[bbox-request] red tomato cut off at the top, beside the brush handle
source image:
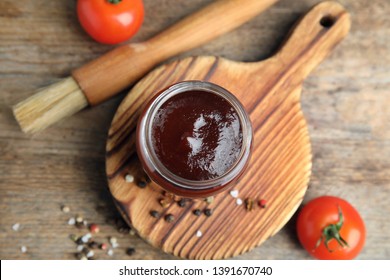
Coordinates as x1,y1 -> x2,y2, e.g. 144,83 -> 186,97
77,0 -> 144,44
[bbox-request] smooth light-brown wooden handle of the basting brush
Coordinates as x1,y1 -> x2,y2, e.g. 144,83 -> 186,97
72,0 -> 277,106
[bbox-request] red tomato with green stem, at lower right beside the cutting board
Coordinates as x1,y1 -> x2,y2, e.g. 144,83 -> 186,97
297,196 -> 366,260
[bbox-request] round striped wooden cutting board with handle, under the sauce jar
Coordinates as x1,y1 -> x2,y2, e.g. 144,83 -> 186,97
106,2 -> 350,259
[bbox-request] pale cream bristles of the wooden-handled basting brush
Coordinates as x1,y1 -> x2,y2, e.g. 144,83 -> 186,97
13,77 -> 88,133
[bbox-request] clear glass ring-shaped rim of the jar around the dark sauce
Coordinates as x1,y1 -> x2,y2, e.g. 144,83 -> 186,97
137,80 -> 252,190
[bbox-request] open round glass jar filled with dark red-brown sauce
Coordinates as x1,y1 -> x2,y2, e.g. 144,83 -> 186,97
136,81 -> 253,198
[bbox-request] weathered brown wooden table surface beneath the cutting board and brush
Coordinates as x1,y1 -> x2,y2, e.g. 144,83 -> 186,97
0,0 -> 390,259
